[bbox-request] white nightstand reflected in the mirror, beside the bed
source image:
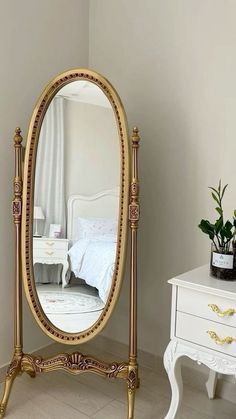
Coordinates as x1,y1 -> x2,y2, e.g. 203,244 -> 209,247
33,237 -> 69,288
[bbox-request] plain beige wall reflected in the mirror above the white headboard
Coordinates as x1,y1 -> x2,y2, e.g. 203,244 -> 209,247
65,100 -> 120,199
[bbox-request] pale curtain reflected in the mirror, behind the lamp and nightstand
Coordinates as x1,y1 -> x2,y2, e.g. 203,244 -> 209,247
34,97 -> 66,283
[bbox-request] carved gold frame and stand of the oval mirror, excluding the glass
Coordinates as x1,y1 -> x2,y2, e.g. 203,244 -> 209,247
0,69 -> 140,419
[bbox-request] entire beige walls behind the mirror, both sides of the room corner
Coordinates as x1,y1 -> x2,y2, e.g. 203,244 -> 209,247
0,0 -> 236,366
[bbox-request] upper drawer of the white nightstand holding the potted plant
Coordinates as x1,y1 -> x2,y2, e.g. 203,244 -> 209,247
177,287 -> 236,327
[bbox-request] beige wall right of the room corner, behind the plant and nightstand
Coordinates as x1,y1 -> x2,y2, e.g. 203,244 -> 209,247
89,0 -> 236,354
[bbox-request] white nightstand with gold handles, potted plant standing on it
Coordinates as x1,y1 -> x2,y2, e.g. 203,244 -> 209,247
164,265 -> 236,419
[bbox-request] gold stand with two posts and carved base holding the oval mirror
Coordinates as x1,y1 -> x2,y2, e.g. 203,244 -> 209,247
0,127 -> 140,419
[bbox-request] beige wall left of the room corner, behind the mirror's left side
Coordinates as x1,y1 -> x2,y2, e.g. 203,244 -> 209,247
0,0 -> 88,366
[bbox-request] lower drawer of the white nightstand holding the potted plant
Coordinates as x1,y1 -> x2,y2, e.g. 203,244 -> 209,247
176,312 -> 236,356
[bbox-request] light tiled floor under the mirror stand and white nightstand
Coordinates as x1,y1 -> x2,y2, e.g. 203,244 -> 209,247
1,344 -> 236,419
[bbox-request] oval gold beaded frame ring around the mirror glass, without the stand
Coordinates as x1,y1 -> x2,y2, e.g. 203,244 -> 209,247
21,69 -> 130,345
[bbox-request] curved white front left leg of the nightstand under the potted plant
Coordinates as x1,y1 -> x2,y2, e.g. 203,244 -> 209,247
164,342 -> 183,419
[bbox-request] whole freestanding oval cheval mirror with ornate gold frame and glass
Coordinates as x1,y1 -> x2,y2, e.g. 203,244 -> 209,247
0,69 -> 139,419
